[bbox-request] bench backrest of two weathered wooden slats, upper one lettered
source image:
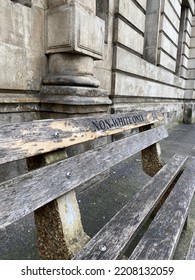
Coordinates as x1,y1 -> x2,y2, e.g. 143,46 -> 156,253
0,111 -> 168,228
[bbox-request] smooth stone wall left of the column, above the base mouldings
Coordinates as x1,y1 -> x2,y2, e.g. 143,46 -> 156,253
0,1 -> 46,90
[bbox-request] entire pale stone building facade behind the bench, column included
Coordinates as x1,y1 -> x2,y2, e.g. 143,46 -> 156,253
0,0 -> 195,125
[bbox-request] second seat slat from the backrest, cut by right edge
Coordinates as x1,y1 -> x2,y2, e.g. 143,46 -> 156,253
130,160 -> 195,260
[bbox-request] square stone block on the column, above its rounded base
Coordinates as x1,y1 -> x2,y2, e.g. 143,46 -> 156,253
46,4 -> 105,59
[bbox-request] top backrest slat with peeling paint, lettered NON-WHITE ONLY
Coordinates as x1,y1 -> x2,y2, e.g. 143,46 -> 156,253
0,111 -> 163,164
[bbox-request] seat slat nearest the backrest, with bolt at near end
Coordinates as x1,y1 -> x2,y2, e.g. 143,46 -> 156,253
75,155 -> 186,260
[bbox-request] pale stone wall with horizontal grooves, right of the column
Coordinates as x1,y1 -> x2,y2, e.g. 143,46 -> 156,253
108,0 -> 194,123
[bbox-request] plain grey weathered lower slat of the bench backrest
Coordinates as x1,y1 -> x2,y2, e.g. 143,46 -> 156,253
0,126 -> 167,228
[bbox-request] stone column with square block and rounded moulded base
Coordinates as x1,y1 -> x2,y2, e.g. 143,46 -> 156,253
41,0 -> 111,116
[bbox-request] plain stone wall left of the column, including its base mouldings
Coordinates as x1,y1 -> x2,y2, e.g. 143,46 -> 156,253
0,0 -> 46,123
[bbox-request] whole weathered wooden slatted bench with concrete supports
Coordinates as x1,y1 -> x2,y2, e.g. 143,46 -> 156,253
0,111 -> 195,259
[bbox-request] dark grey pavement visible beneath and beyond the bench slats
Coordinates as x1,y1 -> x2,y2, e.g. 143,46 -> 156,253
0,124 -> 195,259
